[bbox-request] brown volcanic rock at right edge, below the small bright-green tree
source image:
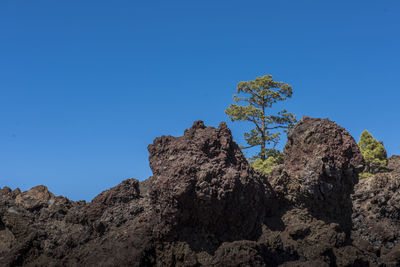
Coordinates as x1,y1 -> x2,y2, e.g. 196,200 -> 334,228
352,156 -> 400,266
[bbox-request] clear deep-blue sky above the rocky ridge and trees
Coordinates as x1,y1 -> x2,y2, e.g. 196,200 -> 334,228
0,0 -> 400,200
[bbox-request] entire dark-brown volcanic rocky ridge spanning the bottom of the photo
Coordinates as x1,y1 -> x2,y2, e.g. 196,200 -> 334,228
0,117 -> 400,266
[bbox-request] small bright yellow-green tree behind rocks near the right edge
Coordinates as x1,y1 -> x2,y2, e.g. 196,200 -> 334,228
358,130 -> 387,173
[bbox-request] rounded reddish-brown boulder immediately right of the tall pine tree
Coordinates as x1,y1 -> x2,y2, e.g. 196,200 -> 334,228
272,117 -> 364,224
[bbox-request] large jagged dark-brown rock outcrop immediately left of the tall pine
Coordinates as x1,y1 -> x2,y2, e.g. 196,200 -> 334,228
148,121 -> 271,246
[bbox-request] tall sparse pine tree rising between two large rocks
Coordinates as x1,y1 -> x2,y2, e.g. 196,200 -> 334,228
225,75 -> 296,161
